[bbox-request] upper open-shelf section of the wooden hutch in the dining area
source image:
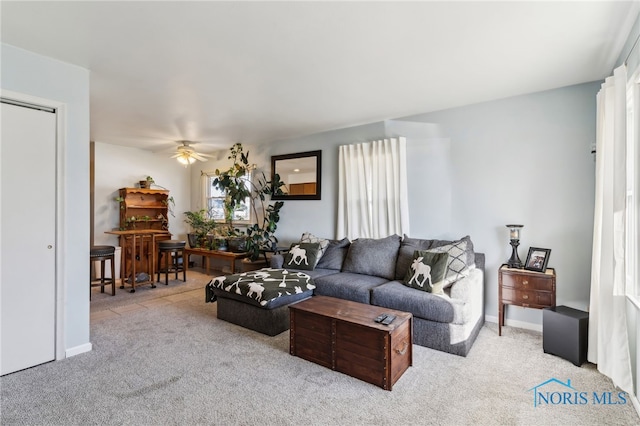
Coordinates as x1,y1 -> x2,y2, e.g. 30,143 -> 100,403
120,188 -> 169,230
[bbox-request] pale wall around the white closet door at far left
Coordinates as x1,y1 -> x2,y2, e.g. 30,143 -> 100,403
1,44 -> 91,355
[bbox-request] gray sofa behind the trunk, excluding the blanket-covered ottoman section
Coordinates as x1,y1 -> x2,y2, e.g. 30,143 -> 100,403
271,235 -> 484,356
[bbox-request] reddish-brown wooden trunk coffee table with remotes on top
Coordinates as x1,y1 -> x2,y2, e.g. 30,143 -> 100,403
289,296 -> 413,390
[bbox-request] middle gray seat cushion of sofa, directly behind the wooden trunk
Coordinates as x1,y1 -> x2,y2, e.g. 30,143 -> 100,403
313,272 -> 388,304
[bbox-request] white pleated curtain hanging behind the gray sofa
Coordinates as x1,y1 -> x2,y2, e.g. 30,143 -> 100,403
336,137 -> 409,240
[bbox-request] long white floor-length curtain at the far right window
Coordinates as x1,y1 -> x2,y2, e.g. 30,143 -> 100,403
587,66 -> 633,393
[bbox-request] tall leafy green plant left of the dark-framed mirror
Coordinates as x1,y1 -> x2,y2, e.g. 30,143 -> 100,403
213,143 -> 284,260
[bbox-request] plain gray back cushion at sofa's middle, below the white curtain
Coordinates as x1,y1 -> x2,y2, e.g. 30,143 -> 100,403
342,235 -> 406,280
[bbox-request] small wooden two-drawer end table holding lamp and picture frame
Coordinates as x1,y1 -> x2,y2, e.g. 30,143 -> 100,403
498,265 -> 556,336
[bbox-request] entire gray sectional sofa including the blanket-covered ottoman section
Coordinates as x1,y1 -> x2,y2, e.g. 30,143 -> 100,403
207,235 -> 485,356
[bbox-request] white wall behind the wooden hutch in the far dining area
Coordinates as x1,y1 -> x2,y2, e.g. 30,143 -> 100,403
94,142 -> 191,245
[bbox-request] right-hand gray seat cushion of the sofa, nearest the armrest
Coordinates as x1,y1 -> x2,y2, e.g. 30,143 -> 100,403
370,281 -> 471,324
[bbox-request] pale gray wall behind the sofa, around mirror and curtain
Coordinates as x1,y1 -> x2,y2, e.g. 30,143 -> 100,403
258,82 -> 600,329
